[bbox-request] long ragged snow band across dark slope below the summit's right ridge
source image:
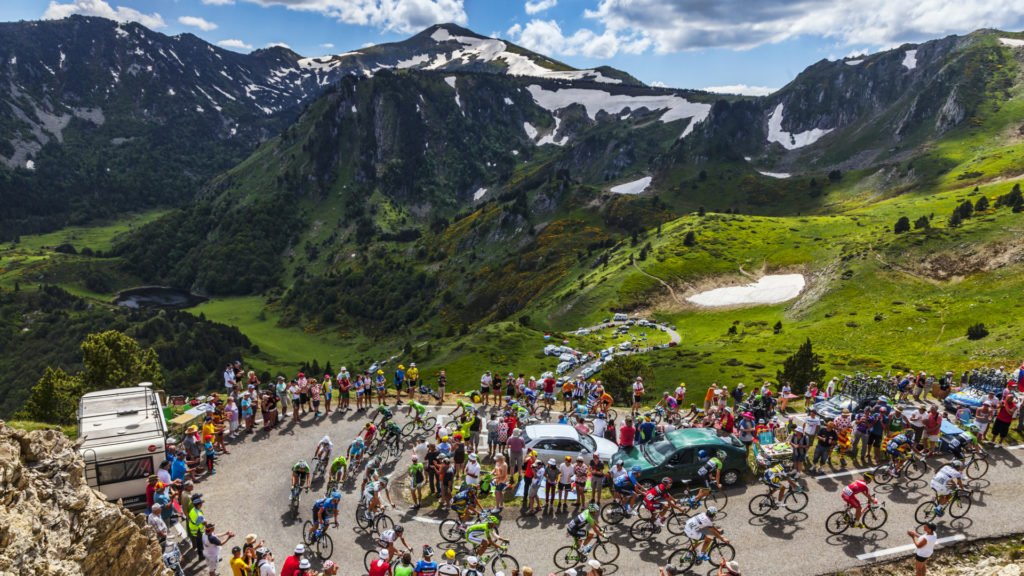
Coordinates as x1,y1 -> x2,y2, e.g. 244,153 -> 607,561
526,84 -> 711,138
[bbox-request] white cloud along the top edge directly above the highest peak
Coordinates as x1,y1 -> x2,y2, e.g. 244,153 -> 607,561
239,0 -> 469,34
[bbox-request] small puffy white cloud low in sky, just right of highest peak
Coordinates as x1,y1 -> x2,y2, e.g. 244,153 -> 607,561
506,19 -> 650,58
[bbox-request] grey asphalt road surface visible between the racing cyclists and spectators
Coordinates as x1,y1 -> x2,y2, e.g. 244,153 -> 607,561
197,408 -> 1024,575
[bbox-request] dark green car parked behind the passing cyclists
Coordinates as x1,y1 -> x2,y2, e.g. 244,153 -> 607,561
611,428 -> 748,486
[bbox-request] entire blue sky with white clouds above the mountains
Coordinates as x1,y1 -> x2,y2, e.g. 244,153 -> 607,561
8,0 -> 1024,93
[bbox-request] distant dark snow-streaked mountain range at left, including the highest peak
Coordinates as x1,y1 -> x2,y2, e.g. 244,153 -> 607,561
0,16 -> 640,239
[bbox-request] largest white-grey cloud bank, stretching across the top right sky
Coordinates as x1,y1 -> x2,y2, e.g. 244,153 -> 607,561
585,0 -> 1024,52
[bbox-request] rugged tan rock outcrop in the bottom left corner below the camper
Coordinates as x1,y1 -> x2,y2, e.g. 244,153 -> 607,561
0,421 -> 169,576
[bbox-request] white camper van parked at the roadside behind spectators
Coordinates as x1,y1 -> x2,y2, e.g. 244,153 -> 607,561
78,382 -> 167,508
